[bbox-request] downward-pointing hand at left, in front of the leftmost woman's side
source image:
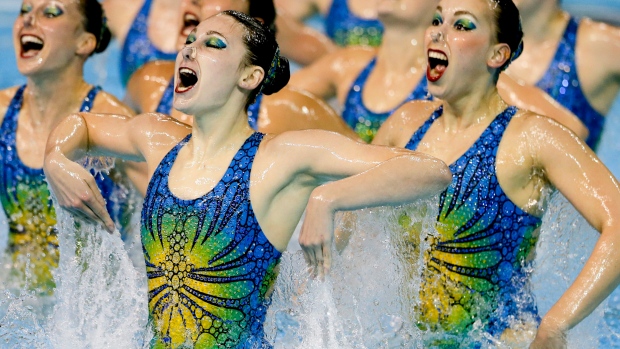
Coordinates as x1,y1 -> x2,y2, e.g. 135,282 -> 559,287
44,154 -> 115,233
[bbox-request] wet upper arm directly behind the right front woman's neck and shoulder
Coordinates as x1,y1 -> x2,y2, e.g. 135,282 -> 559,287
497,74 -> 589,139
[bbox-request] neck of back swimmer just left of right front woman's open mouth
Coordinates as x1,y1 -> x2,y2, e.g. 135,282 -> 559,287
377,20 -> 427,74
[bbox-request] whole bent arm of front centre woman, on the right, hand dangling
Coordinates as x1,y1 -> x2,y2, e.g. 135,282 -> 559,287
268,131 -> 452,274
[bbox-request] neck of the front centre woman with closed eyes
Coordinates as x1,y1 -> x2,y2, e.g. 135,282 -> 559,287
190,98 -> 254,163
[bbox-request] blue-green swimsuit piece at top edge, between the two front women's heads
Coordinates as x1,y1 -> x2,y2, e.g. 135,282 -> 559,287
325,0 -> 383,47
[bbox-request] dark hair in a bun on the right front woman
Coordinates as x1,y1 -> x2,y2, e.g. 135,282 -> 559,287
490,0 -> 523,71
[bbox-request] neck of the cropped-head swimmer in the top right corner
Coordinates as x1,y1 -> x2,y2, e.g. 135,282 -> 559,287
521,1 -> 567,41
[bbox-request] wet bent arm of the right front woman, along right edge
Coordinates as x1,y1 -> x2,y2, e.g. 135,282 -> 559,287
528,114 -> 620,348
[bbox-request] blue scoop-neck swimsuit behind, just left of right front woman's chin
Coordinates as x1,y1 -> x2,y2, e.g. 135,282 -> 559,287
342,58 -> 431,143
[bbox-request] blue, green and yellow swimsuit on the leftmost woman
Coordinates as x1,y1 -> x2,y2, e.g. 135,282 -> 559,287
0,85 -> 118,291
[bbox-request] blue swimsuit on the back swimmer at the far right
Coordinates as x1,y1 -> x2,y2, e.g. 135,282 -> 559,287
536,17 -> 605,149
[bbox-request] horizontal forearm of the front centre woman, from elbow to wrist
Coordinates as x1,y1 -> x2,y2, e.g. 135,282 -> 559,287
311,155 -> 452,212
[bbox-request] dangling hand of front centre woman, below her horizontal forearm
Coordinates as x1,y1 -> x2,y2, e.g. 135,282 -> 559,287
299,187 -> 334,278
